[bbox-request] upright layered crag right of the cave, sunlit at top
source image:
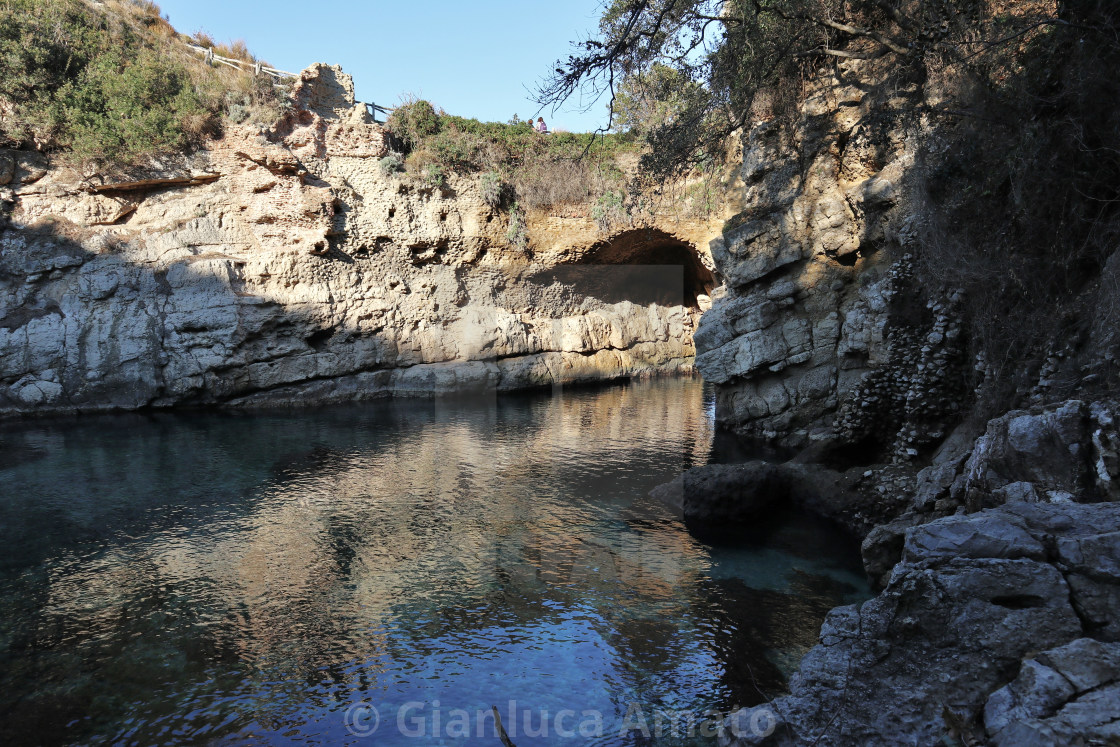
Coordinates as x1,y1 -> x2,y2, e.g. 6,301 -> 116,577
696,60 -> 962,458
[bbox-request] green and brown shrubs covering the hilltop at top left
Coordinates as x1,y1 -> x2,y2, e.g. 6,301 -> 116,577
0,0 -> 282,164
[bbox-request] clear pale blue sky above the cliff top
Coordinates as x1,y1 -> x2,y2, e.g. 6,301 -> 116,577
159,0 -> 606,132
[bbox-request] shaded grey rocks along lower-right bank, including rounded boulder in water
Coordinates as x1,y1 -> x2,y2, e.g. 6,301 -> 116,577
654,401 -> 1120,746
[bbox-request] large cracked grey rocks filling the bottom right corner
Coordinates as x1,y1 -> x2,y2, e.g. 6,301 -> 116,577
720,503 -> 1120,745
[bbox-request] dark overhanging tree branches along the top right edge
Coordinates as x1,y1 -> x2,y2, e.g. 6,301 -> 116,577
536,0 -> 1070,175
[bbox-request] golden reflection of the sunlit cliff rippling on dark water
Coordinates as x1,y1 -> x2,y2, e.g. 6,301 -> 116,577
168,383 -> 710,647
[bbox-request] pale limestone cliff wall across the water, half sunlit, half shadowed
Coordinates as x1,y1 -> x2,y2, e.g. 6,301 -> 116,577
0,65 -> 718,414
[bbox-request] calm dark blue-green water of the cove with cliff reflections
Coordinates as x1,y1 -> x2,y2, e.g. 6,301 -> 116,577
0,380 -> 868,747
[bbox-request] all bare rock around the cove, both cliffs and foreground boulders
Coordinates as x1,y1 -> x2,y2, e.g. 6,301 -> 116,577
0,36 -> 1120,746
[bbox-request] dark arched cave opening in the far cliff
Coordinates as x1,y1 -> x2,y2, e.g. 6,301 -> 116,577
535,228 -> 717,309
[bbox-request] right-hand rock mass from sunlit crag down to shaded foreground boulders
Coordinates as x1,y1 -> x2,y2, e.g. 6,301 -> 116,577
689,49 -> 1120,747
